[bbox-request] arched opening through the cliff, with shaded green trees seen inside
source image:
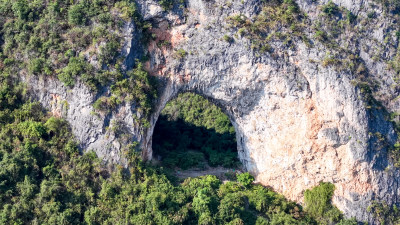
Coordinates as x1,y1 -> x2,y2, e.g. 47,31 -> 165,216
152,92 -> 240,176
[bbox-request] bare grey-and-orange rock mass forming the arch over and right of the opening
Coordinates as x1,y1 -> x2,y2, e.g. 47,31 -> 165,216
138,1 -> 399,222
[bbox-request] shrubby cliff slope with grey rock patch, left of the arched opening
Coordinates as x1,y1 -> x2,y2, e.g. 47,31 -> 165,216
0,0 -> 162,162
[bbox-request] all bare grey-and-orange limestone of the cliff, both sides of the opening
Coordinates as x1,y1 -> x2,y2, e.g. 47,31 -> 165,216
27,0 -> 400,223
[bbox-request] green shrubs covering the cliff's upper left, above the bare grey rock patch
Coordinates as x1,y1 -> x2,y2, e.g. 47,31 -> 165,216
0,0 -> 159,119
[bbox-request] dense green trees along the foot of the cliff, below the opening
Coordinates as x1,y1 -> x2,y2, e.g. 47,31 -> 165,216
0,75 -> 362,225
